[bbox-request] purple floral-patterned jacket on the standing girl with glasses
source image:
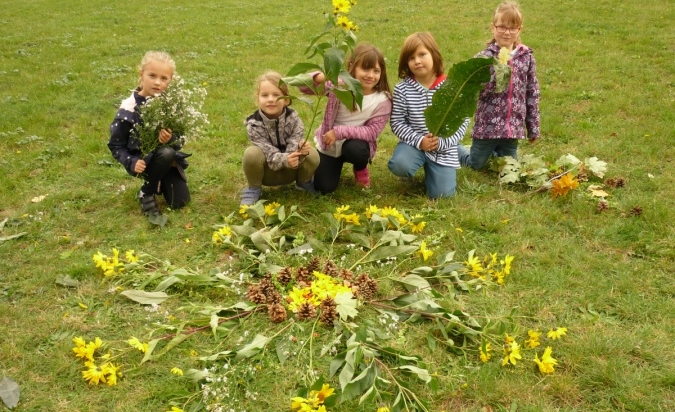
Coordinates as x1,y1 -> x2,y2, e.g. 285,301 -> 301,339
471,43 -> 539,140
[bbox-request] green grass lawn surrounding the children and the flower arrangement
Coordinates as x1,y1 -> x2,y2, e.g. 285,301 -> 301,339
0,0 -> 675,412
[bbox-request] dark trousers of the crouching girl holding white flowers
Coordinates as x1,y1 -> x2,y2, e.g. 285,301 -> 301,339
141,146 -> 190,209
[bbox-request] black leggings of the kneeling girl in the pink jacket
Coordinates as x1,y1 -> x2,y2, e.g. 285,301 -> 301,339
314,139 -> 370,194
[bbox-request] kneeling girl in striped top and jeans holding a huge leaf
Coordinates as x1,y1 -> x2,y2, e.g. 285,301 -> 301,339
388,32 -> 469,199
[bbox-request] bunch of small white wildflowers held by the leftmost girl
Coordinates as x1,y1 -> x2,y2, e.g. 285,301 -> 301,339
136,76 -> 209,154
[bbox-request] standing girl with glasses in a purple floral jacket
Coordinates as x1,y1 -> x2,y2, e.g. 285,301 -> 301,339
458,2 -> 539,169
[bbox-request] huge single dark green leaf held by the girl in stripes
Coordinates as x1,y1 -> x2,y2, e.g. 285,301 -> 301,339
424,57 -> 495,137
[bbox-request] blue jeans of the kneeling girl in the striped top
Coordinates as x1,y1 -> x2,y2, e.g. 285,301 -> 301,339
387,142 -> 457,199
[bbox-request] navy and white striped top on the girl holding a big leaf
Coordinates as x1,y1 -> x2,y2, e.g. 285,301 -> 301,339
389,77 -> 469,169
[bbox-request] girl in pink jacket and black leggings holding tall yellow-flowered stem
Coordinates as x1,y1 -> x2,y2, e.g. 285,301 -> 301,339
306,44 -> 391,194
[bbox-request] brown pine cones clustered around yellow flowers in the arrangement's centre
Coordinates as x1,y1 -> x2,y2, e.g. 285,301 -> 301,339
246,257 -> 377,326
